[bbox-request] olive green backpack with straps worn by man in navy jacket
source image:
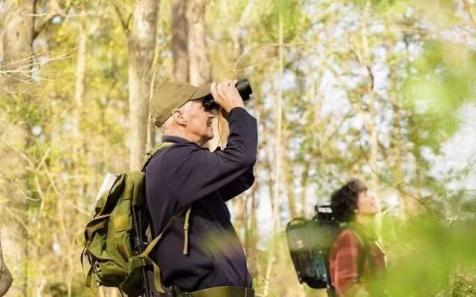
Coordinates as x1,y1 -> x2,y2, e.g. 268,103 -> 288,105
81,143 -> 191,296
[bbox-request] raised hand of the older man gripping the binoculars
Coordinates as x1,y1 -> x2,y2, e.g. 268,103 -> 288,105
210,80 -> 244,114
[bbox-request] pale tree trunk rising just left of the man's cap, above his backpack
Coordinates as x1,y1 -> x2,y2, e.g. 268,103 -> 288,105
128,0 -> 159,170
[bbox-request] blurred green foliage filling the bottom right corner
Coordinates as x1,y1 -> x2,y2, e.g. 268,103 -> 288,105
380,214 -> 476,297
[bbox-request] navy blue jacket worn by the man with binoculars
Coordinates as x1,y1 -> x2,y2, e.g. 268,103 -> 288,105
145,107 -> 258,292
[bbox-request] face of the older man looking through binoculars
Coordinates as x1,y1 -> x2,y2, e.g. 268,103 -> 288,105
184,100 -> 216,145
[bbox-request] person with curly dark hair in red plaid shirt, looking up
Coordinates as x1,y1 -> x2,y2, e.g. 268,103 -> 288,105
329,179 -> 385,297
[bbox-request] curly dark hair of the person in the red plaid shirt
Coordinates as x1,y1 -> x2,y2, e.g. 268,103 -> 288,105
331,178 -> 367,223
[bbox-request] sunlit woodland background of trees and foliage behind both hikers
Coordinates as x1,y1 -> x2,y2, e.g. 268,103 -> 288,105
0,0 -> 476,297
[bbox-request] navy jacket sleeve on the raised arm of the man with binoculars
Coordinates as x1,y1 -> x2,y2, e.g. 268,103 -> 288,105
162,107 -> 258,207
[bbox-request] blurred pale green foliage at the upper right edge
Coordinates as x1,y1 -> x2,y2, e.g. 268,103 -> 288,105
404,41 -> 476,134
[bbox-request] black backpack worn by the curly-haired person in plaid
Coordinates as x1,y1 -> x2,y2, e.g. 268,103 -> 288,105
286,205 -> 340,289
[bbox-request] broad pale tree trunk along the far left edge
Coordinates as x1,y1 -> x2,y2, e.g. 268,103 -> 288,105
0,0 -> 34,296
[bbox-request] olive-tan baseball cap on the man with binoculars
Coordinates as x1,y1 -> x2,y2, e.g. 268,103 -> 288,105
150,82 -> 210,126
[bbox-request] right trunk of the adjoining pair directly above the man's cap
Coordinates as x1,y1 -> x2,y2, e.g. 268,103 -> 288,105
187,0 -> 211,85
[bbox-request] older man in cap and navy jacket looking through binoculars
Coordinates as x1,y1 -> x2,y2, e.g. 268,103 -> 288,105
145,80 -> 258,297
